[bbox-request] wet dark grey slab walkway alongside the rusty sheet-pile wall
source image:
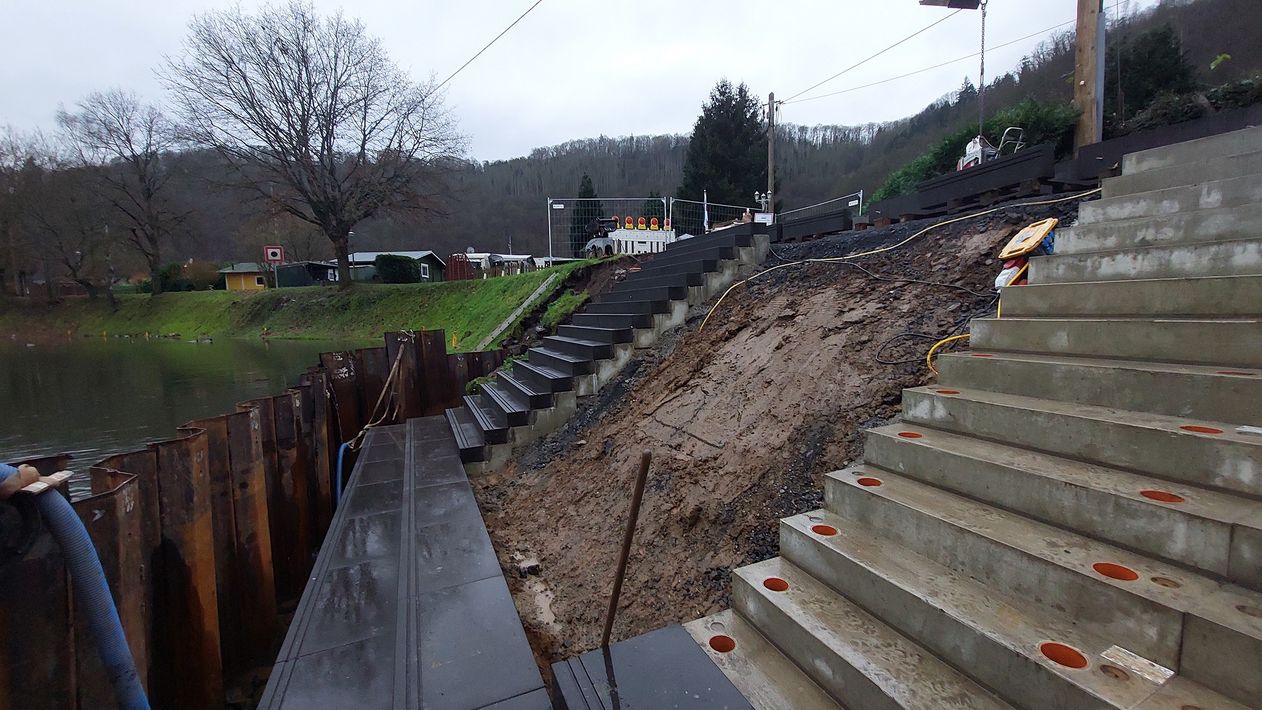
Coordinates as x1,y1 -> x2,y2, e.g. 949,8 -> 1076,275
260,416 -> 551,710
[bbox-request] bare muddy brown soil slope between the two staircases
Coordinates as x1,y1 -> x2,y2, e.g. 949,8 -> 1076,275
475,202 -> 1078,676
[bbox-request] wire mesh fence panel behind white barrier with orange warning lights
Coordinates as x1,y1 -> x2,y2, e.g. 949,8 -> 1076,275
548,197 -> 668,259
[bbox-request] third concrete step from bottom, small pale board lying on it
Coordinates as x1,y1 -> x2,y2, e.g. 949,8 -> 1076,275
780,511 -> 1234,709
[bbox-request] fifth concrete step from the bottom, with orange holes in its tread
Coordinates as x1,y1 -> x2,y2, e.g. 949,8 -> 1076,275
863,422 -> 1262,590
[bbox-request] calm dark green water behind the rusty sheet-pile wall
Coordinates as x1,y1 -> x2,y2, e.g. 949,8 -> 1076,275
0,338 -> 377,494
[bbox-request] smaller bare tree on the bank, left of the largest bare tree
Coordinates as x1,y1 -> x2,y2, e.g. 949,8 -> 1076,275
57,90 -> 184,294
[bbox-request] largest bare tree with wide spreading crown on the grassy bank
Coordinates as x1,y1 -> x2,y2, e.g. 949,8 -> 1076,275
163,1 -> 462,288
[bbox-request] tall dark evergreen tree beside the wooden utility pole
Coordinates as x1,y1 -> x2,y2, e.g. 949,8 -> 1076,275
678,79 -> 767,204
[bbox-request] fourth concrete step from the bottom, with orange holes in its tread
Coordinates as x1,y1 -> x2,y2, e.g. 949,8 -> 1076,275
822,465 -> 1262,701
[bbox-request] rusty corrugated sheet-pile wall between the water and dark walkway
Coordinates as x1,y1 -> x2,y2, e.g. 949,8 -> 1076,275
0,330 -> 504,710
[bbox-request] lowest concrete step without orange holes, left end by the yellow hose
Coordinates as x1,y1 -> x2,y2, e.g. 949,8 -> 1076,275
969,318 -> 1262,367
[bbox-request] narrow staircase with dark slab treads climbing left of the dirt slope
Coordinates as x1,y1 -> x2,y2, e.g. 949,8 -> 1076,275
447,224 -> 770,474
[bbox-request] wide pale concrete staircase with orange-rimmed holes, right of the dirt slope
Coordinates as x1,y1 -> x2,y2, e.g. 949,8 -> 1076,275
688,129 -> 1262,710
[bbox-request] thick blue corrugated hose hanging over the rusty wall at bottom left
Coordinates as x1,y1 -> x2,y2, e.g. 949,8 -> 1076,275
0,464 -> 149,710
